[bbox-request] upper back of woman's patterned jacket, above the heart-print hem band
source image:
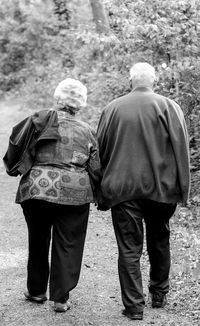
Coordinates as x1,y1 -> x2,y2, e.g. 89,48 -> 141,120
35,111 -> 95,172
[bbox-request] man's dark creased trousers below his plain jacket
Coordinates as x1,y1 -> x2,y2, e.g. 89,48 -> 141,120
111,199 -> 176,312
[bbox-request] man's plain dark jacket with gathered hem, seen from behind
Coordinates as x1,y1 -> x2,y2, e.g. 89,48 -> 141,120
97,87 -> 190,207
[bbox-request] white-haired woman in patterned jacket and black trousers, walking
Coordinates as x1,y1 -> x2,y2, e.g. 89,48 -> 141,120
4,78 -> 100,312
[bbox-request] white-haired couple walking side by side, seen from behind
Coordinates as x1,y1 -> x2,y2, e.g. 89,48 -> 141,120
4,62 -> 190,320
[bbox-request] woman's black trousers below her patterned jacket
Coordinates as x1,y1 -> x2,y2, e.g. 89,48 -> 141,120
22,199 -> 89,303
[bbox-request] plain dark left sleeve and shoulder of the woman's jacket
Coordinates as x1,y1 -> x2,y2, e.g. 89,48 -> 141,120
3,110 -> 60,176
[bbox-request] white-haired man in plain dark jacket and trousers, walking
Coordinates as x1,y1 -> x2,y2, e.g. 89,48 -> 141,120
97,63 -> 190,320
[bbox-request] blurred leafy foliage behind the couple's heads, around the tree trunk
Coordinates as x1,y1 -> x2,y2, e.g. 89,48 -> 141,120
0,0 -> 200,170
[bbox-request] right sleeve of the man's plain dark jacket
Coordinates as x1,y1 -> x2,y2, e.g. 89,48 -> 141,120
167,101 -> 190,203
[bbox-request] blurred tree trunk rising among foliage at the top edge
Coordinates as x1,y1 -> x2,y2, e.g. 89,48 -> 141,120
90,0 -> 110,34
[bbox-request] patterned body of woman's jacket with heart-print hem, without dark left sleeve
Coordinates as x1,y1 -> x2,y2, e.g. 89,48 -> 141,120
16,111 -> 100,205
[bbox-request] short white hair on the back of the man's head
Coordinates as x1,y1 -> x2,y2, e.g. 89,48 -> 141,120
130,62 -> 156,85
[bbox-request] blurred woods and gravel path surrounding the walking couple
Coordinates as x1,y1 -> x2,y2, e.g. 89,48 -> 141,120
0,0 -> 200,326
